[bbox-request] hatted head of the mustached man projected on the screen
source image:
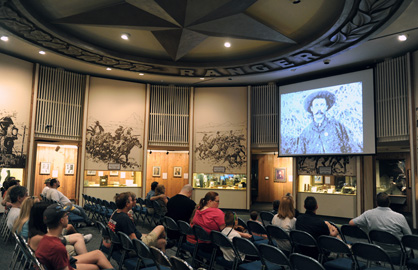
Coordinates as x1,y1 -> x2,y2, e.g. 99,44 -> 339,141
304,91 -> 335,123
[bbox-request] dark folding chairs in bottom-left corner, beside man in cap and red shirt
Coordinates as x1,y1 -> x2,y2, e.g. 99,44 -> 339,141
9,233 -> 46,270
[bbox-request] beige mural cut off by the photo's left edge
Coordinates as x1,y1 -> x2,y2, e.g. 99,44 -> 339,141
0,54 -> 33,168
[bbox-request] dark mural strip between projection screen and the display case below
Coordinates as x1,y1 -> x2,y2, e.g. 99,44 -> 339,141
297,156 -> 356,176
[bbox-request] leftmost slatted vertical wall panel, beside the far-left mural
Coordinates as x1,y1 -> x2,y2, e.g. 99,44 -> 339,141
35,66 -> 86,140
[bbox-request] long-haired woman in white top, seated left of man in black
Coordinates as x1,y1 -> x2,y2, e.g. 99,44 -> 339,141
271,196 -> 296,251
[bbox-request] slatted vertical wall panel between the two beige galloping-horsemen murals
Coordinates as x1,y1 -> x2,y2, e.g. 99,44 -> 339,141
148,85 -> 190,146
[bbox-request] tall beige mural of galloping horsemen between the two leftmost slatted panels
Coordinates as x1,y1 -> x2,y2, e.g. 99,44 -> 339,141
85,78 -> 145,171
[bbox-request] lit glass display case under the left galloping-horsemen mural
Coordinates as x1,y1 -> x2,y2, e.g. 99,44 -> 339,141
84,170 -> 142,187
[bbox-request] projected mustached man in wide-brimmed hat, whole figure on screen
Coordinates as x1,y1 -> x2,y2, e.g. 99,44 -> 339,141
298,91 -> 351,154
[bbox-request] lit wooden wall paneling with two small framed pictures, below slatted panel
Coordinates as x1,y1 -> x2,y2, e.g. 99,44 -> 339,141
145,151 -> 190,197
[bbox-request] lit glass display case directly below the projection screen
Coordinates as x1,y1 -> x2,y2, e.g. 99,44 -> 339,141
298,175 -> 357,195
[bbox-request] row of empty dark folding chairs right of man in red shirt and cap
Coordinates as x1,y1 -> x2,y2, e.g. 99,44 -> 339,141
96,221 -> 193,270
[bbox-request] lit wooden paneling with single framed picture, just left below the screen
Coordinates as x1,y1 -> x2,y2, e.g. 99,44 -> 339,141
254,154 -> 293,202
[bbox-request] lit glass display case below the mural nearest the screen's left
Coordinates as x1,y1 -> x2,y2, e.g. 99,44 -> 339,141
193,173 -> 247,190
